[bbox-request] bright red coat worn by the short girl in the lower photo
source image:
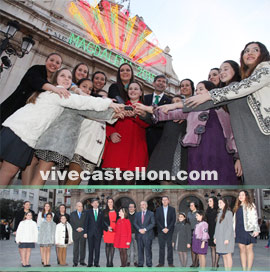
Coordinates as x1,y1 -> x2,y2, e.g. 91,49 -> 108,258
114,218 -> 131,248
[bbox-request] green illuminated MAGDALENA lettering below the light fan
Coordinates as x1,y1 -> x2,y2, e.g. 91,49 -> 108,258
68,33 -> 156,83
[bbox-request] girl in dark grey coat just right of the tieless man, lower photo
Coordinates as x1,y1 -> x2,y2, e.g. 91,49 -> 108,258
172,213 -> 191,267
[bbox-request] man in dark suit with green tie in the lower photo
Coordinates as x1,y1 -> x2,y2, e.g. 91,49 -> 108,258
83,199 -> 104,267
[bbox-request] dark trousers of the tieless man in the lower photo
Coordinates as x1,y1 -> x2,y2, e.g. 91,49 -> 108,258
158,232 -> 173,265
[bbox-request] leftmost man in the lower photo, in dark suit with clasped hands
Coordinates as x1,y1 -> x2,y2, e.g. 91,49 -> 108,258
70,202 -> 86,267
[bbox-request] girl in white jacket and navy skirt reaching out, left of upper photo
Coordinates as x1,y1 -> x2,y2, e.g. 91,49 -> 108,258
0,68 -> 121,185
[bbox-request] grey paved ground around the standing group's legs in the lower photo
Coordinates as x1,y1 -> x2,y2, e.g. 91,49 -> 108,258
0,236 -> 270,271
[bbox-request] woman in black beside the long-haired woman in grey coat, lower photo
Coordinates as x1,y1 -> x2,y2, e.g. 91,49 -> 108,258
205,196 -> 219,267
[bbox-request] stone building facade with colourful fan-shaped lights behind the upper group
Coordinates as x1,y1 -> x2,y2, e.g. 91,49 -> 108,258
0,0 -> 179,102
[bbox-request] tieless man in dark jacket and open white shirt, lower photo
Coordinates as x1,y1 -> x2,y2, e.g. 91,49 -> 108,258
156,196 -> 176,267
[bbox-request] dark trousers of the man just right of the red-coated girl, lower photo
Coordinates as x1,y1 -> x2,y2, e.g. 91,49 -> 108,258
137,235 -> 152,267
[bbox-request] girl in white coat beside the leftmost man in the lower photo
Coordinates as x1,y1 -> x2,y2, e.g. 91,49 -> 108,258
55,215 -> 73,266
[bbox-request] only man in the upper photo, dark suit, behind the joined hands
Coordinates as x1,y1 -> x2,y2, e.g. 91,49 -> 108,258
141,75 -> 171,157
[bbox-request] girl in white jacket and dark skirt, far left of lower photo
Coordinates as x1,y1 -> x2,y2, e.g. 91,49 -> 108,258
15,212 -> 38,267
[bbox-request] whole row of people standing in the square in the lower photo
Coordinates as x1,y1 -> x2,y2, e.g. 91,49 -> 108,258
11,191 -> 260,270
